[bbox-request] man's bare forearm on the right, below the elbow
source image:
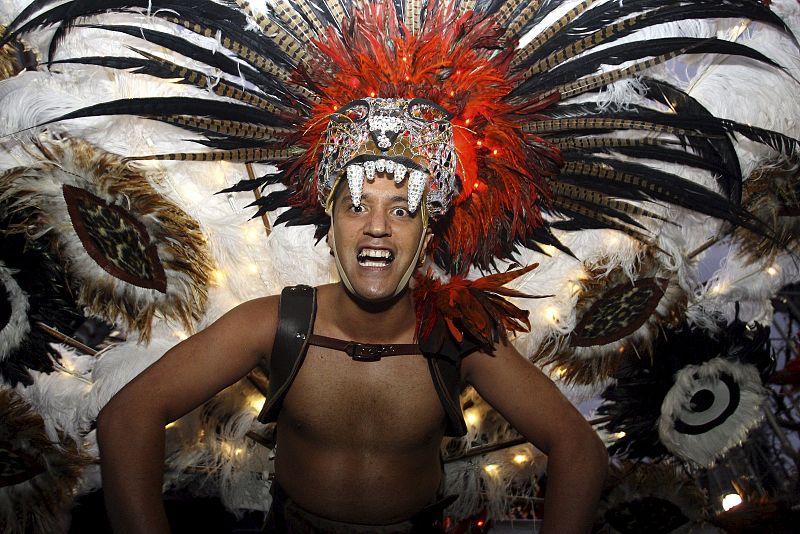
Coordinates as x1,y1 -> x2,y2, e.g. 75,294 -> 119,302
540,434 -> 608,534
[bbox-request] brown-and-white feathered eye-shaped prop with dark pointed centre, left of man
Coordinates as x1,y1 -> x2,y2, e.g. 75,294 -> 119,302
0,139 -> 211,339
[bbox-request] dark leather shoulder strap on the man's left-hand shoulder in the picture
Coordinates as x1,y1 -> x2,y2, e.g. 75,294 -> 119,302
258,285 -> 317,423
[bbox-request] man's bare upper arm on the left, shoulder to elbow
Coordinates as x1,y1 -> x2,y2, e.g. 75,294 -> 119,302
103,296 -> 278,428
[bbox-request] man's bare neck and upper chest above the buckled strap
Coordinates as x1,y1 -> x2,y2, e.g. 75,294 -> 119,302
330,282 -> 416,343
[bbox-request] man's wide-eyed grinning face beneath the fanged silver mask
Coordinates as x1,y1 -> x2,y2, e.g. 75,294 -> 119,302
331,173 -> 430,302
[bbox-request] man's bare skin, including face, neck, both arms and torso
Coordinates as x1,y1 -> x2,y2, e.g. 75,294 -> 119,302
98,178 -> 607,534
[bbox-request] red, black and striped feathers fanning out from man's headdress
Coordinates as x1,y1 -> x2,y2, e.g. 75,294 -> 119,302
0,0 -> 797,280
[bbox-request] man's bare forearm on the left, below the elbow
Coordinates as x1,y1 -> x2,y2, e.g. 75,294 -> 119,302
97,399 -> 169,534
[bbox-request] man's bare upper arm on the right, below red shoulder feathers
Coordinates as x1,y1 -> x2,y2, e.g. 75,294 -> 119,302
462,343 -> 594,454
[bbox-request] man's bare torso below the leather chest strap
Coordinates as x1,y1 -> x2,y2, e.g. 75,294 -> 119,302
276,286 -> 445,524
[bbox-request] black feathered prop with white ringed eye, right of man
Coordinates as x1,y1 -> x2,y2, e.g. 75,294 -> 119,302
598,322 -> 772,467
